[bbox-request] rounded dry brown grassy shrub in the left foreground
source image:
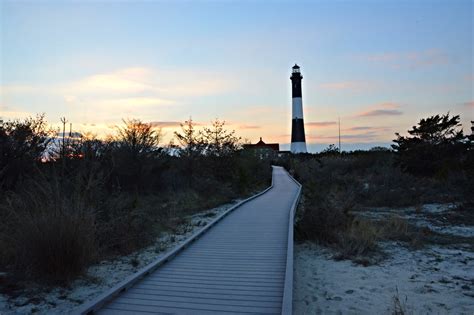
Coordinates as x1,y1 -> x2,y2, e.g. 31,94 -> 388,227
0,181 -> 96,283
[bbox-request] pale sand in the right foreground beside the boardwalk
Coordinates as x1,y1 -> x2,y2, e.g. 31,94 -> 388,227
293,243 -> 474,315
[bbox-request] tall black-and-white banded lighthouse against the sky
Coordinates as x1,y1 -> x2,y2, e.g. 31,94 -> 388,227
290,64 -> 307,153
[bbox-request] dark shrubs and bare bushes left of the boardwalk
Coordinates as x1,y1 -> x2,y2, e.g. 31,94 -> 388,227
0,116 -> 271,284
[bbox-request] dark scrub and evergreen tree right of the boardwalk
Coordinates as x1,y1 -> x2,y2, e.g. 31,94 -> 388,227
279,114 -> 474,264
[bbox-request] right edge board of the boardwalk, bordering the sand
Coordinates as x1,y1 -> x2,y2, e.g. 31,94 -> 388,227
281,170 -> 301,315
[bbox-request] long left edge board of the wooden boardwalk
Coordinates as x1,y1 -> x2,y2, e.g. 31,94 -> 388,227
72,176 -> 274,315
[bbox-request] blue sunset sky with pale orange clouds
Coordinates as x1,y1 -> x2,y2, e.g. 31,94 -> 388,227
0,0 -> 474,152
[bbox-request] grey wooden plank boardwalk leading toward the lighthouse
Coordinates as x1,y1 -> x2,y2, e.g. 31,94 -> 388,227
78,167 -> 300,314
